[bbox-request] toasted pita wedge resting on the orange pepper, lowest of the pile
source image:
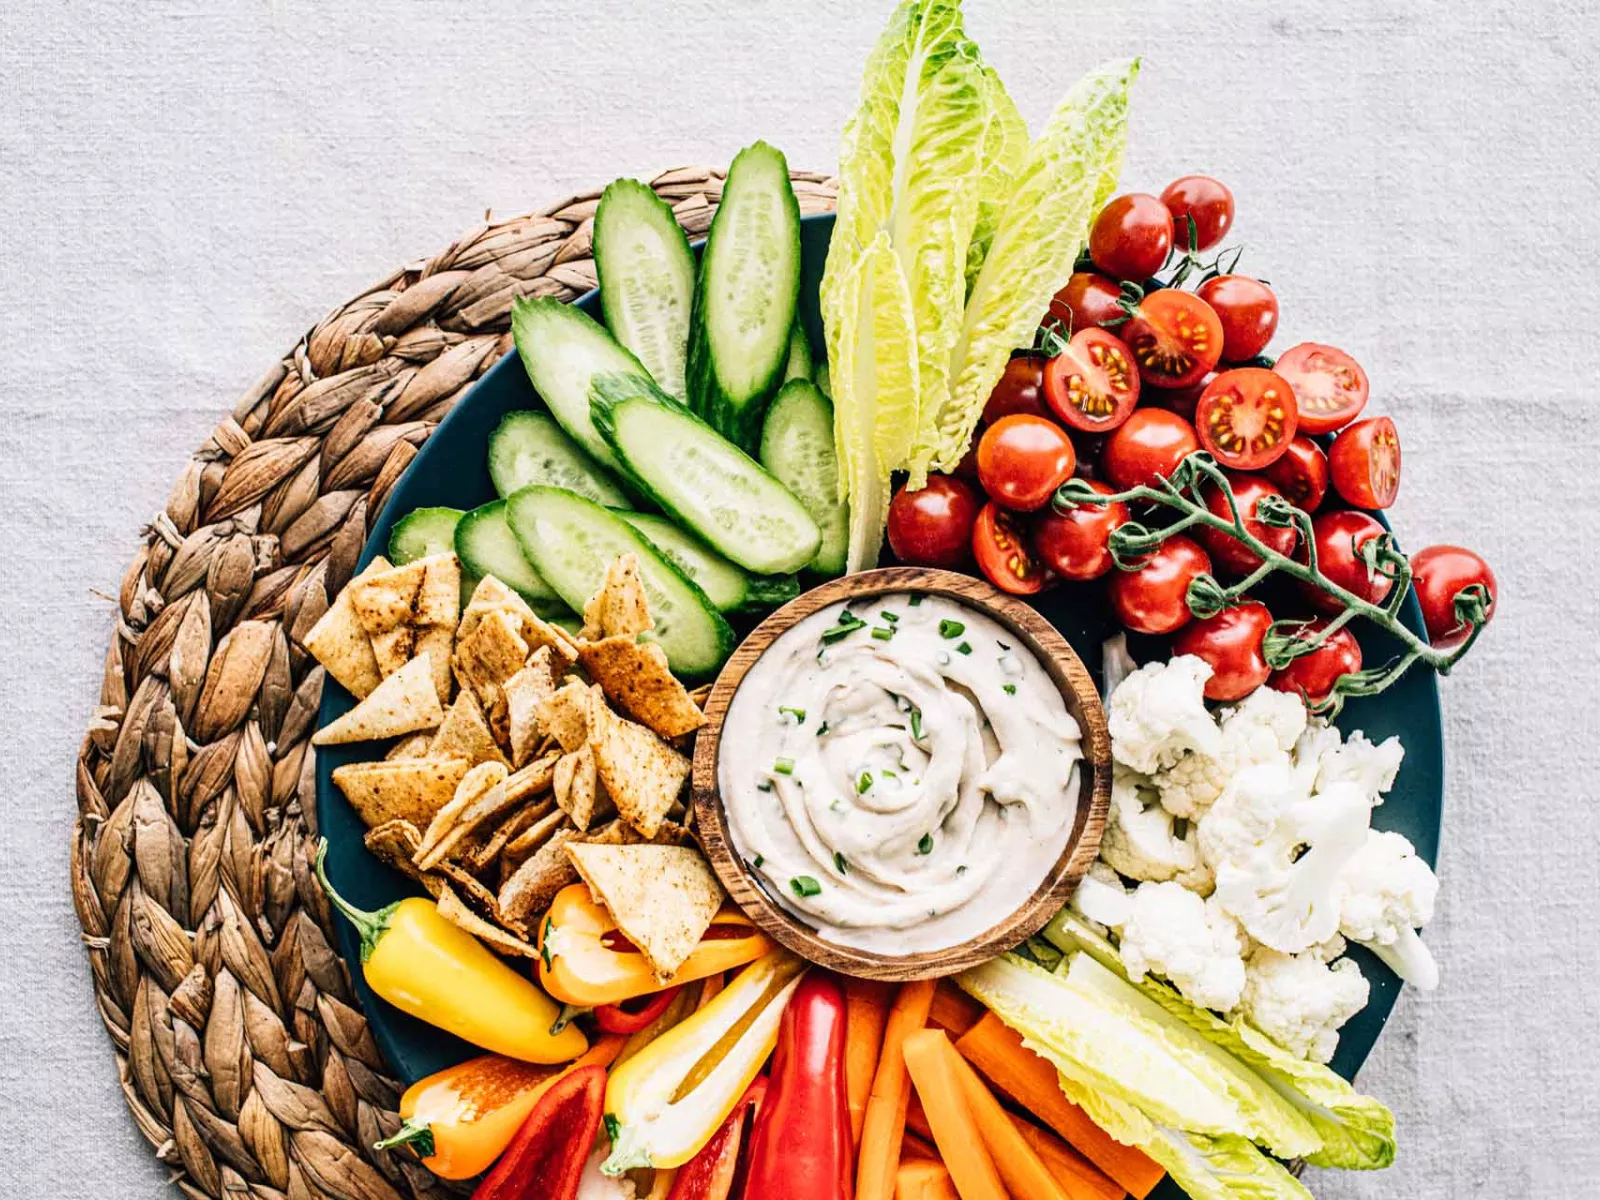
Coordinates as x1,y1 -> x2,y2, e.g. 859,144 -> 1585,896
566,842 -> 723,982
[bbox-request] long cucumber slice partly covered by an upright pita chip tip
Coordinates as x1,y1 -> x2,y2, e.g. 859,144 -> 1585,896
506,486 -> 733,677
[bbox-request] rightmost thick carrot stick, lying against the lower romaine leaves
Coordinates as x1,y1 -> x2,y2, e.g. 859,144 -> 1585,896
955,1013 -> 1165,1200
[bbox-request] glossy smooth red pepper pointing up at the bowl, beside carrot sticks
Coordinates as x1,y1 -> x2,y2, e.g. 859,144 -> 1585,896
744,971 -> 854,1200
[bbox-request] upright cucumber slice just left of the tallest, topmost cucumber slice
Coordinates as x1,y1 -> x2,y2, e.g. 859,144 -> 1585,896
594,179 -> 694,404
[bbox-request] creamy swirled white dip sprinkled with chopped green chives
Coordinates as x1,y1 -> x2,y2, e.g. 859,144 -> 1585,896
717,594 -> 1082,955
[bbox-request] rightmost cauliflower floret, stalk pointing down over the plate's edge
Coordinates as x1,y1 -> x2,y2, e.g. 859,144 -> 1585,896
1338,829 -> 1438,992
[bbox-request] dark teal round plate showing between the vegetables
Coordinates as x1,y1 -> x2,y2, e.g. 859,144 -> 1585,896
317,214 -> 1445,1120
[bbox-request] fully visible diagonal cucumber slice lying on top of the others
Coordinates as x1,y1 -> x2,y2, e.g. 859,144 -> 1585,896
592,374 -> 822,574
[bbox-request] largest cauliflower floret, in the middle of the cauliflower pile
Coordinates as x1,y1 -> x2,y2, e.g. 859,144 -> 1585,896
1198,758 -> 1371,954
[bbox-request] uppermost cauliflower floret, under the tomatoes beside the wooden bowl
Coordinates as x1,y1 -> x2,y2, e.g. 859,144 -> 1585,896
1106,654 -> 1222,774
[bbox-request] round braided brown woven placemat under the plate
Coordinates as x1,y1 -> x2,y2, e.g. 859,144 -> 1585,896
70,168 -> 834,1200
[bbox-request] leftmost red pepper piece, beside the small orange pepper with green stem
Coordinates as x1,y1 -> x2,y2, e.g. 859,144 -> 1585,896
472,1064 -> 606,1200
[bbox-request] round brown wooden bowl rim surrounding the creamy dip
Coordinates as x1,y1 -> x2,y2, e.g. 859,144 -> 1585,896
693,566 -> 1110,981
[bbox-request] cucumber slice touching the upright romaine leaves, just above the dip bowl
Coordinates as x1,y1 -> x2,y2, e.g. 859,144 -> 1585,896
762,379 -> 850,574
